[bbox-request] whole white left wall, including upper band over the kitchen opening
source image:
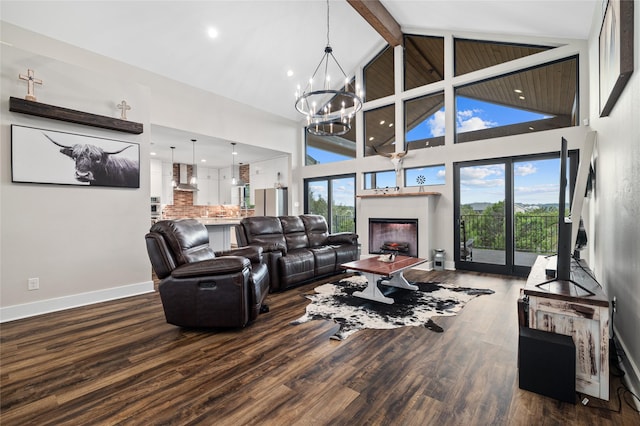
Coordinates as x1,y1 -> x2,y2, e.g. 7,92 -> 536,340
0,22 -> 300,321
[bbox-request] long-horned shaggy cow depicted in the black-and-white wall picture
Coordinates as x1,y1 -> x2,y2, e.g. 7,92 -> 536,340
44,134 -> 140,188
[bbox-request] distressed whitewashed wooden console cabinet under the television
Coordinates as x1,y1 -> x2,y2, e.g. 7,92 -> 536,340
523,256 -> 609,400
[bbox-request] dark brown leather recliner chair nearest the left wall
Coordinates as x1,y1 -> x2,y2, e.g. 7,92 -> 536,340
145,219 -> 269,327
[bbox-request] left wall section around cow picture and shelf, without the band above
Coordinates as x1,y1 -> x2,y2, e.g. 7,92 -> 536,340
0,46 -> 153,321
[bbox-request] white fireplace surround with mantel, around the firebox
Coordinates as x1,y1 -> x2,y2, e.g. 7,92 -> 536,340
356,192 -> 440,269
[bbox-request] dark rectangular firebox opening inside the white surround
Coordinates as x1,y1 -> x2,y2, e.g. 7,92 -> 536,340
369,218 -> 418,257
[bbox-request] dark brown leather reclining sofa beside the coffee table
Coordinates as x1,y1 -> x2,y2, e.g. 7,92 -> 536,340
236,215 -> 358,291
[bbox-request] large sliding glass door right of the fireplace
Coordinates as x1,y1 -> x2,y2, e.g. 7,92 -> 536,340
454,153 -> 576,276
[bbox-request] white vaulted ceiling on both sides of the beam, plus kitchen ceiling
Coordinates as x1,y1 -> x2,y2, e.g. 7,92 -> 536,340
0,0 -> 601,167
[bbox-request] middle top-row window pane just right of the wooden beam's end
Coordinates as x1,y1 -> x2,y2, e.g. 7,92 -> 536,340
404,35 -> 444,90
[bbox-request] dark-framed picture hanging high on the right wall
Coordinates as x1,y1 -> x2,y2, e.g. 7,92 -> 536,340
599,0 -> 634,117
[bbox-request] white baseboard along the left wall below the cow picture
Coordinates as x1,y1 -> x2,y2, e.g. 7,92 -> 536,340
0,281 -> 154,323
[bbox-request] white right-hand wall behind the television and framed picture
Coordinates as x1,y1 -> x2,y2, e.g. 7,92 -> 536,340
588,2 -> 640,391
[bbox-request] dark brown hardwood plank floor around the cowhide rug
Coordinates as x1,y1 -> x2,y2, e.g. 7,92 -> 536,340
0,270 -> 640,426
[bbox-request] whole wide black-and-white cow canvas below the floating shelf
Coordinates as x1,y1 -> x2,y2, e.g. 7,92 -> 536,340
11,124 -> 140,188
